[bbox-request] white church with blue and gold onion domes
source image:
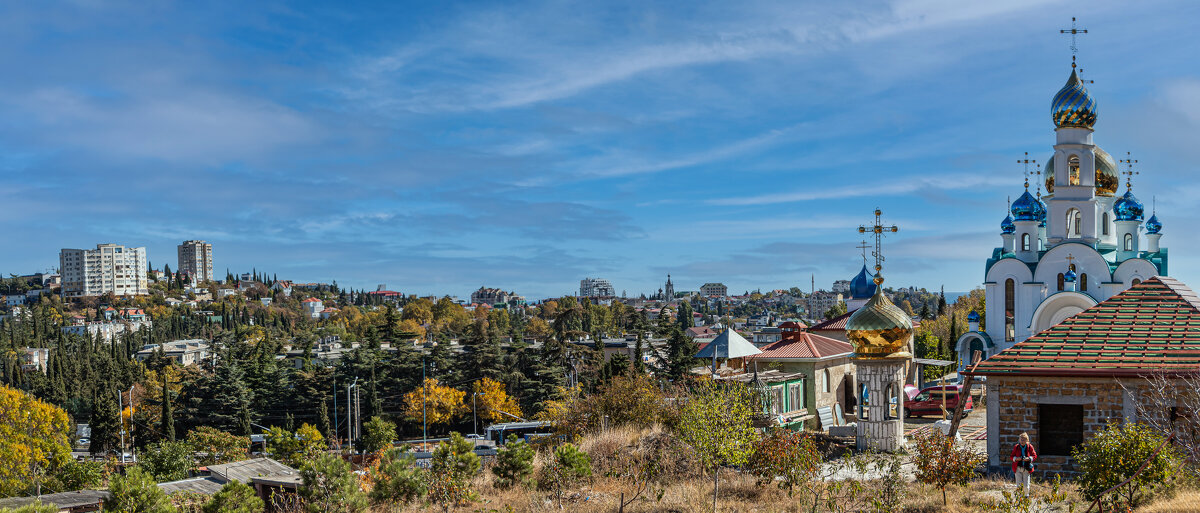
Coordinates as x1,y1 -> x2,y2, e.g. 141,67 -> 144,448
955,59 -> 1168,370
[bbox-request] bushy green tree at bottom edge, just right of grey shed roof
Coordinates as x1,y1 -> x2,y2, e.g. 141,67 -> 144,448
300,454 -> 370,513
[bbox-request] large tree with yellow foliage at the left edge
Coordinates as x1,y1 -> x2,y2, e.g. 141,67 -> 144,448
0,386 -> 71,497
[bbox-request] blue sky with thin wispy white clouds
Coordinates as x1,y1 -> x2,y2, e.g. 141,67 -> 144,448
0,0 -> 1200,298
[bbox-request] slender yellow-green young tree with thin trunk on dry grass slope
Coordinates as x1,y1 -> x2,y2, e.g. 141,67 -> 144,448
679,381 -> 760,511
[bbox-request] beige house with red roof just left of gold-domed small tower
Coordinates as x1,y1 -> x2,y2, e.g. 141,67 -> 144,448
746,322 -> 857,429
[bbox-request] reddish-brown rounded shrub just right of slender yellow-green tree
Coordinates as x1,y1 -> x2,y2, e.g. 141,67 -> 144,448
748,429 -> 821,496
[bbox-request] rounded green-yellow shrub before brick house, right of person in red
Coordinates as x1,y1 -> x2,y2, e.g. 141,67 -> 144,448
1070,422 -> 1180,509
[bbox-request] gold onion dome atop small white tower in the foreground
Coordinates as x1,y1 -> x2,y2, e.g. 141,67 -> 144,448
846,274 -> 912,358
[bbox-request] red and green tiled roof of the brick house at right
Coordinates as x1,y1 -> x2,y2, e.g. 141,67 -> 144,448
976,277 -> 1200,376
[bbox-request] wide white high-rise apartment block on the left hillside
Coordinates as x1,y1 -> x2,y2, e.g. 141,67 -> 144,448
59,245 -> 149,297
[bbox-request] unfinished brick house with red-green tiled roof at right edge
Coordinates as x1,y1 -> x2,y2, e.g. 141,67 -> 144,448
966,277 -> 1200,472
